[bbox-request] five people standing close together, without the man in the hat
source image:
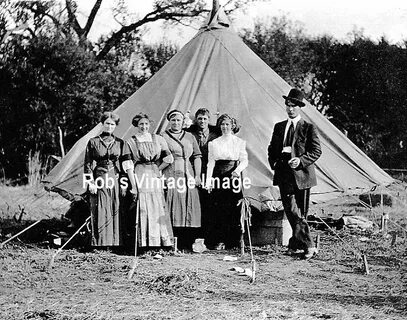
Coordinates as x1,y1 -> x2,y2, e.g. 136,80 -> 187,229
84,108 -> 248,252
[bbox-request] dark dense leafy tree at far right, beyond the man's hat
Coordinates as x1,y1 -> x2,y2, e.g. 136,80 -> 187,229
317,35 -> 407,167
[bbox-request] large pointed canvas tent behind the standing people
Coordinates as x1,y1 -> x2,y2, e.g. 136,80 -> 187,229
44,9 -> 393,201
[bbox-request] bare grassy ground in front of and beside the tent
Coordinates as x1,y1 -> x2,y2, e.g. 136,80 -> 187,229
0,187 -> 407,319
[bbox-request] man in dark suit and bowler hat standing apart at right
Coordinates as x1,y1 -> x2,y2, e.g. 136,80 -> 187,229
268,89 -> 321,259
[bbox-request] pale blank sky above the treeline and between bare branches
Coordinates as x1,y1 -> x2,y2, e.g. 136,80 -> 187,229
77,0 -> 407,46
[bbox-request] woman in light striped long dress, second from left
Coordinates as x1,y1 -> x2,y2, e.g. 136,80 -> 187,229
123,113 -> 174,247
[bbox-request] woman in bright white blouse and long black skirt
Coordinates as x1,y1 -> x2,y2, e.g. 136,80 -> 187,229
206,114 -> 248,249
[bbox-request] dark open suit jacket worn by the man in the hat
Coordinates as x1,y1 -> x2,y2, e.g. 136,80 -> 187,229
268,119 -> 322,190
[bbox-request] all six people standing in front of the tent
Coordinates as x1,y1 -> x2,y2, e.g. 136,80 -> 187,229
84,89 -> 321,259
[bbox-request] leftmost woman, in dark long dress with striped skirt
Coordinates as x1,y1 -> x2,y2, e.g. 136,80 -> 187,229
84,112 -> 123,247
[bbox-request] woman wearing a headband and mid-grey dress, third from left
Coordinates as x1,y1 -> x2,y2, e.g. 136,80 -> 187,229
163,110 -> 201,247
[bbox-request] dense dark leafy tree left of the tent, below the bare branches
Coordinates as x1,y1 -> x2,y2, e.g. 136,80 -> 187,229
0,35 -> 145,181
